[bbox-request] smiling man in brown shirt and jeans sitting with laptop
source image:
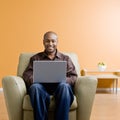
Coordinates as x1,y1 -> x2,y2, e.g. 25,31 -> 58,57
23,31 -> 77,120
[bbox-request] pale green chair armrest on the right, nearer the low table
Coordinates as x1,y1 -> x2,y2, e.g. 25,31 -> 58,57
75,76 -> 97,120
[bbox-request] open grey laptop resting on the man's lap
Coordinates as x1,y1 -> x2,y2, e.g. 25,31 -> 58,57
33,61 -> 67,83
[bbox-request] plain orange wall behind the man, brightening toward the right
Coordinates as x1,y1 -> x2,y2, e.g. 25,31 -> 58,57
0,0 -> 120,86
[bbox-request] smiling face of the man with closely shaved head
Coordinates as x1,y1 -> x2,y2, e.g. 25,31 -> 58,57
43,33 -> 58,53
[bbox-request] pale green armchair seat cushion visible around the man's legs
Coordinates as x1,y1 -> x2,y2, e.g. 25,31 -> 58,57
23,95 -> 77,111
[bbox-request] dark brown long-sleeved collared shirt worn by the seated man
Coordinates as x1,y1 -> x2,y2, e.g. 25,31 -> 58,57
23,51 -> 77,88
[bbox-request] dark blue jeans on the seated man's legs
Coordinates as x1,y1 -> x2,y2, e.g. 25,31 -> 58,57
29,83 -> 74,120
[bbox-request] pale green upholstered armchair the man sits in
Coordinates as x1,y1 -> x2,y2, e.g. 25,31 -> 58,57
2,53 -> 97,120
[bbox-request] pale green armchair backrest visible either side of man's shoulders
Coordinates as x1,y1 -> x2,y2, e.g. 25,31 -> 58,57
17,53 -> 80,77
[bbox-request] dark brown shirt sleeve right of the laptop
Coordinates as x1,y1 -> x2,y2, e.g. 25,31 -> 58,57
67,57 -> 77,85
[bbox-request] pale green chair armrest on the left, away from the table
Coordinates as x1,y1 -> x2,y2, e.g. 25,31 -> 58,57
2,76 -> 27,120
